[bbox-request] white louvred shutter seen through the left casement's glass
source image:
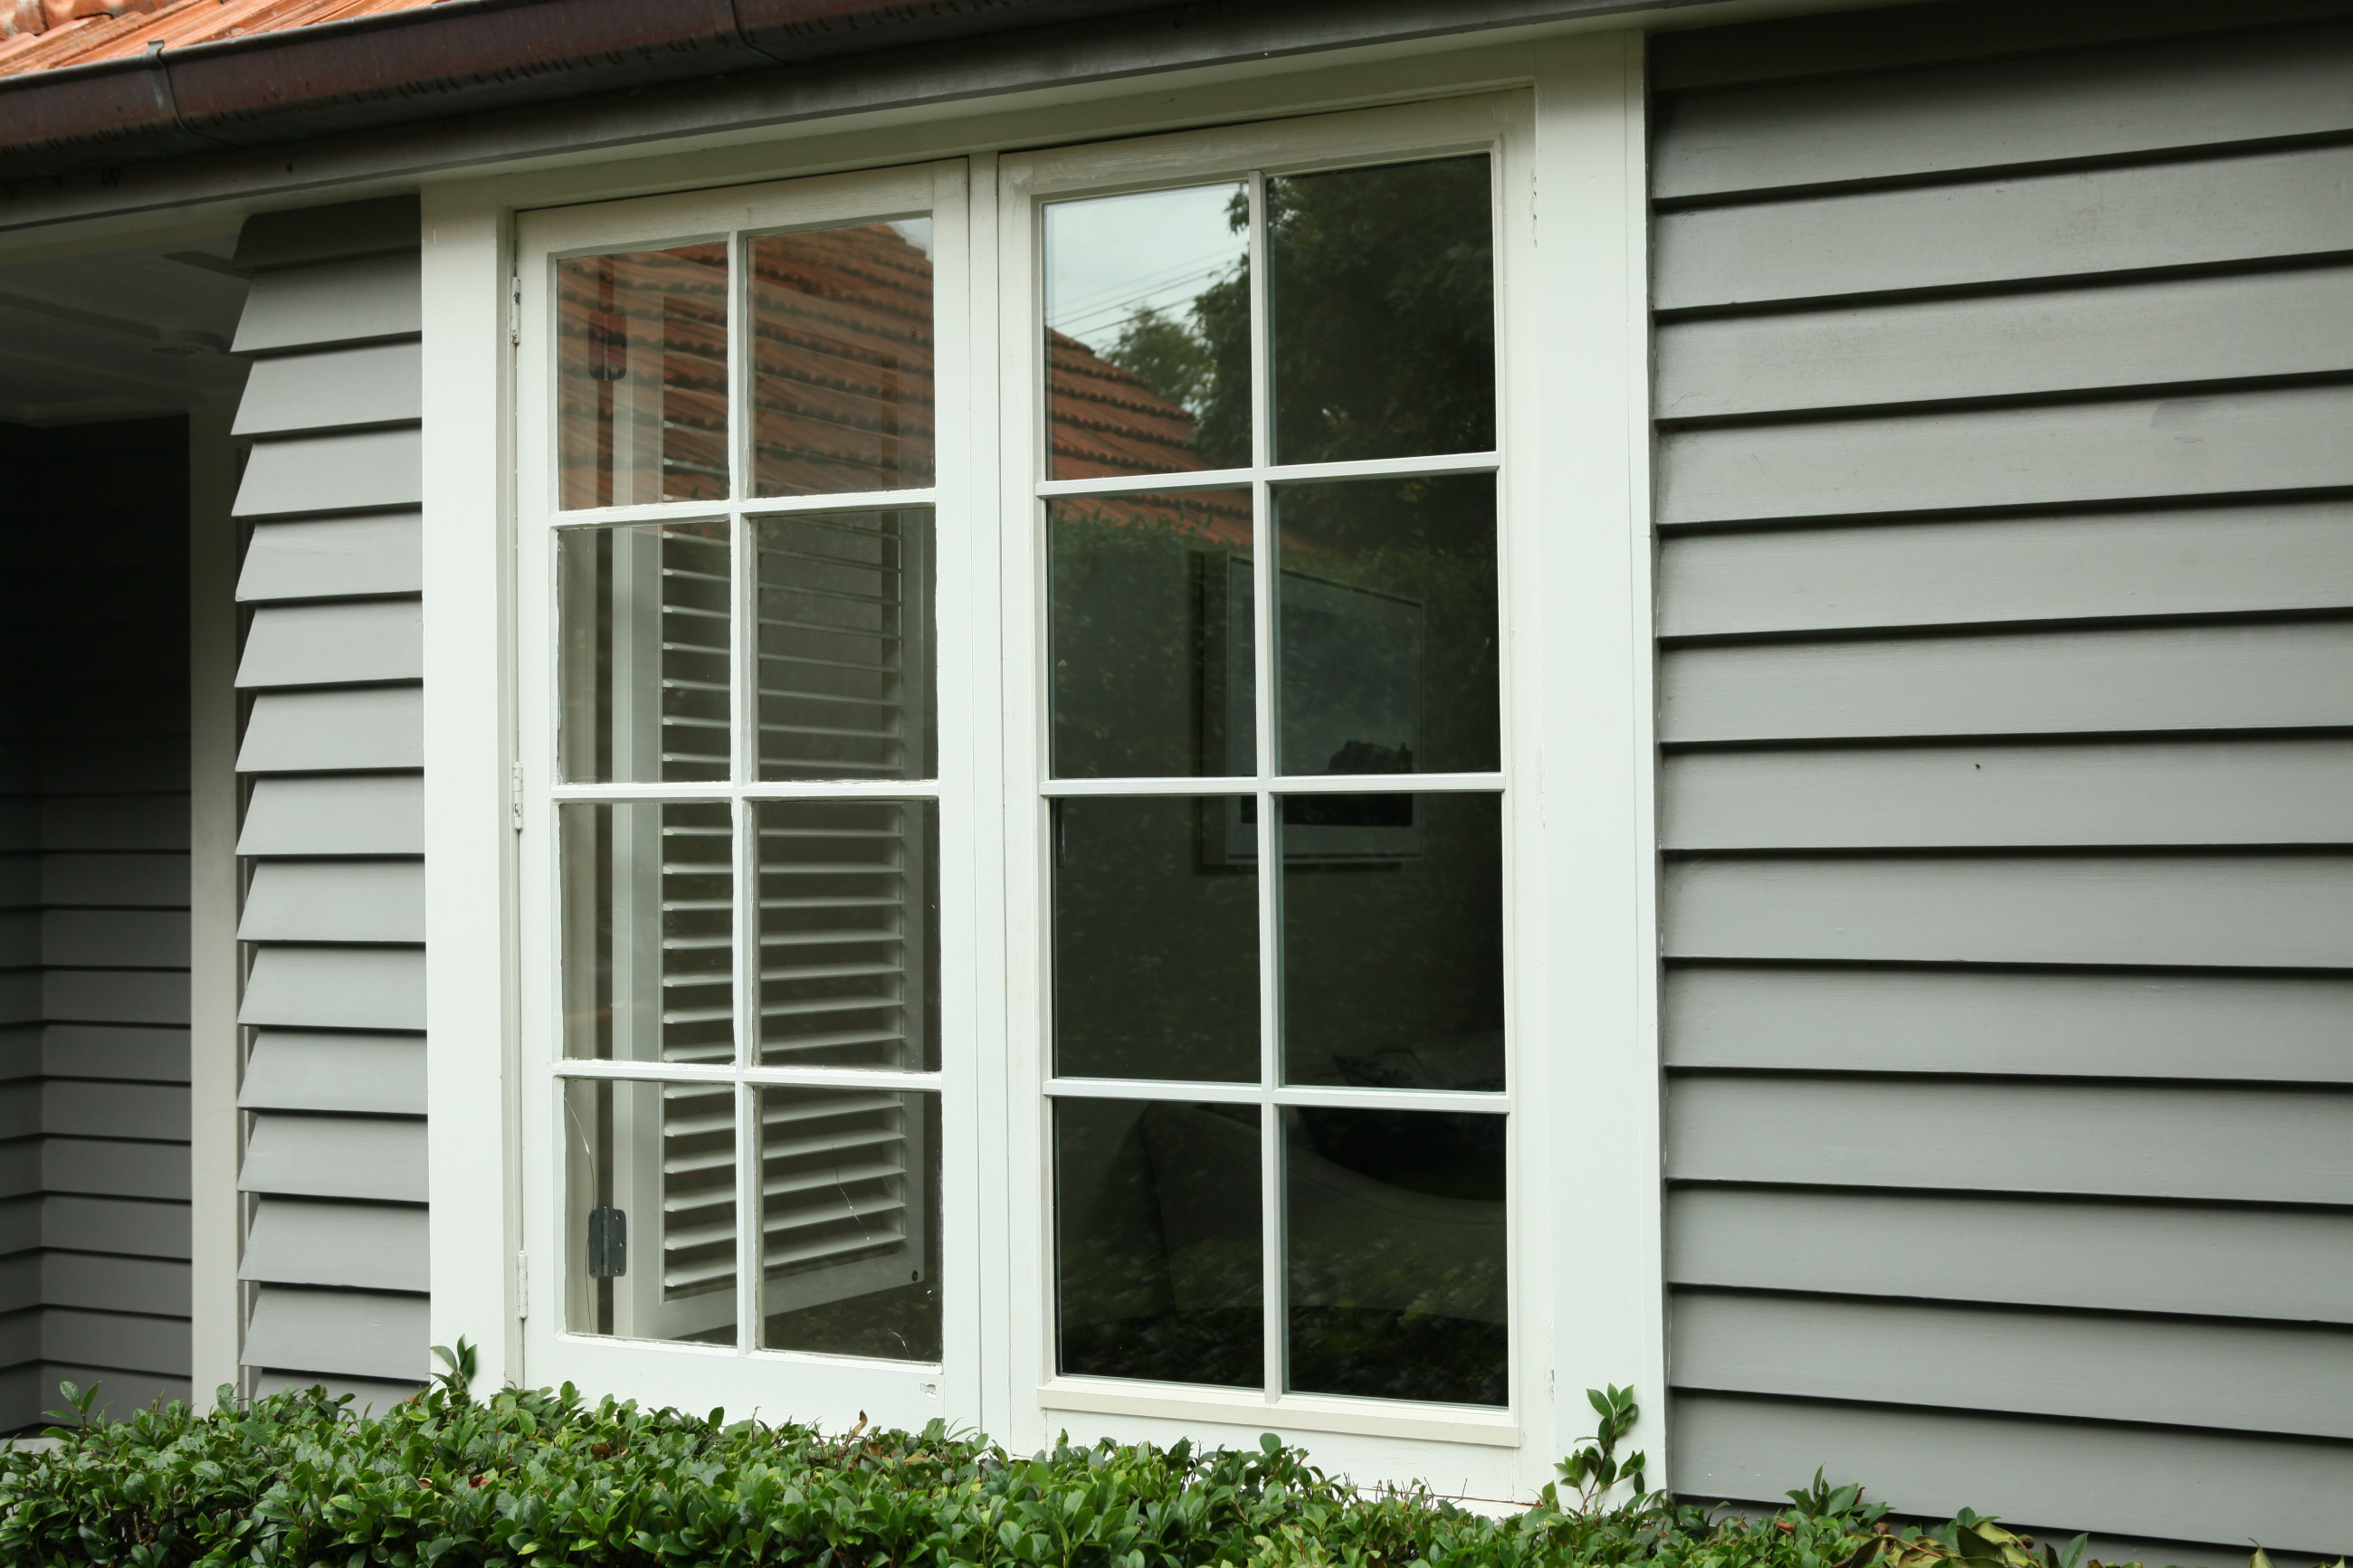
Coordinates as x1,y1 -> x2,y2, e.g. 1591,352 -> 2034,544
600,512 -> 932,1337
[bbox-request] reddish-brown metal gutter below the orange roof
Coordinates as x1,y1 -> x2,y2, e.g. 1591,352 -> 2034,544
0,0 -> 1167,181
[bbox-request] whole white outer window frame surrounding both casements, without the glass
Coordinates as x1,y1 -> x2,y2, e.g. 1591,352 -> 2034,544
424,28 -> 1666,1497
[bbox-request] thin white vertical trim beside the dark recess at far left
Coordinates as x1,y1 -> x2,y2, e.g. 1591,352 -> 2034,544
188,400 -> 244,1408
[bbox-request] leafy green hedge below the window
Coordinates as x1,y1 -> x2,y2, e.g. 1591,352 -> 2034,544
0,1378 -> 2296,1568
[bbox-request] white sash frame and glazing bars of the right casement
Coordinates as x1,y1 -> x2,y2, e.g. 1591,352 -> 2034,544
997,90 -> 1544,1465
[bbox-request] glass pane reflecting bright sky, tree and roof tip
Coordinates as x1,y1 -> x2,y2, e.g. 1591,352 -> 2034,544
1044,184 -> 1250,480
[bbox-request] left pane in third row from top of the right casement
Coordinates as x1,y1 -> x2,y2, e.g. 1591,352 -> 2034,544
1054,794 -> 1259,1084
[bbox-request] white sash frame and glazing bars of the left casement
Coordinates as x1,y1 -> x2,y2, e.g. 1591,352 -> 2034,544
515,160 -> 997,1427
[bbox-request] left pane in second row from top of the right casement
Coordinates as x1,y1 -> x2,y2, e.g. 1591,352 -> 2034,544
1047,489 -> 1259,778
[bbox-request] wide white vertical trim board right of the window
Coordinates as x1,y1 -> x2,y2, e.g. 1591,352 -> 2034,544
1506,33 -> 1671,1486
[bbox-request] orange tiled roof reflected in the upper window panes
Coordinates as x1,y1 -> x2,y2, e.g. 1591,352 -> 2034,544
556,223 -> 1252,547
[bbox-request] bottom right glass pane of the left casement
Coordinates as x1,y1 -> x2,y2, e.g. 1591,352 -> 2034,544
757,1088 -> 938,1361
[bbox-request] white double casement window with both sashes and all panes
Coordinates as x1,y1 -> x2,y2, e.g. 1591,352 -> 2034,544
518,97 -> 1541,1443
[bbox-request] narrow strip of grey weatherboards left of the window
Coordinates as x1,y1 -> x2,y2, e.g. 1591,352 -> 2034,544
235,202 -> 428,1406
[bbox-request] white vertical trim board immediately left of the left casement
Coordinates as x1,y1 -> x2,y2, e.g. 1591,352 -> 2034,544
421,188 -> 527,1387
